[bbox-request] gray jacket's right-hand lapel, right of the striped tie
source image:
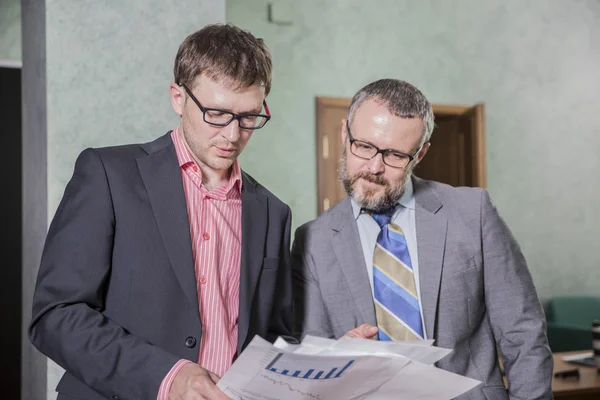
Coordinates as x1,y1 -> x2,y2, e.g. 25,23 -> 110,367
413,178 -> 448,339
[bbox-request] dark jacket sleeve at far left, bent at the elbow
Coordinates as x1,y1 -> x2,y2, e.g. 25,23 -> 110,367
29,149 -> 179,399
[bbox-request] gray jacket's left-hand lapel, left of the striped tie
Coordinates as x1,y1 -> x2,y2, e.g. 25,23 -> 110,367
331,197 -> 377,325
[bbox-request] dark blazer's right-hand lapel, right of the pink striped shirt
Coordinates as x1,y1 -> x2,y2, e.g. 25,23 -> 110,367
238,172 -> 268,352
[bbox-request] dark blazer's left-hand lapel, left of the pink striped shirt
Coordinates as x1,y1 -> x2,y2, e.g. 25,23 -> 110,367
137,134 -> 200,318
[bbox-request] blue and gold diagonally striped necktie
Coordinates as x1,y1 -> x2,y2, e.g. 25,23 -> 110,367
372,209 -> 423,341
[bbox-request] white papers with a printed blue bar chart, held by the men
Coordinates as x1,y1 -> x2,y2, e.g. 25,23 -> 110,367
217,336 -> 480,400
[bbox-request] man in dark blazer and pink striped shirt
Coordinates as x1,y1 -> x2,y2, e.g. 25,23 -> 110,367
29,25 -> 292,400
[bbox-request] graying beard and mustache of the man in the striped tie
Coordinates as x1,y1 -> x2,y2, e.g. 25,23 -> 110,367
339,148 -> 413,213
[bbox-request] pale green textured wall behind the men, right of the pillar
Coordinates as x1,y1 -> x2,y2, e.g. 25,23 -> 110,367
227,0 -> 600,298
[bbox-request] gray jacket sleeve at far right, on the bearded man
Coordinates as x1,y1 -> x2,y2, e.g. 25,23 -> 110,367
481,191 -> 553,400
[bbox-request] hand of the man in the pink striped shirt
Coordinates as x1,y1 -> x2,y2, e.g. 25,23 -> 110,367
169,363 -> 230,400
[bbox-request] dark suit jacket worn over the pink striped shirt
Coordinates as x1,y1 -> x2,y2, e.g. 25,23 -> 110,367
29,134 -> 292,400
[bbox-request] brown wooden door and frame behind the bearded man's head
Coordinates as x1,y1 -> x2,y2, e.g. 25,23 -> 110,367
316,97 -> 486,214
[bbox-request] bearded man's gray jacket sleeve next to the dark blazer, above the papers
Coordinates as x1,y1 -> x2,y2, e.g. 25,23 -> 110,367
292,225 -> 334,339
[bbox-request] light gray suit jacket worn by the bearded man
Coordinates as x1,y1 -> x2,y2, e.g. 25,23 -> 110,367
292,178 -> 553,400
